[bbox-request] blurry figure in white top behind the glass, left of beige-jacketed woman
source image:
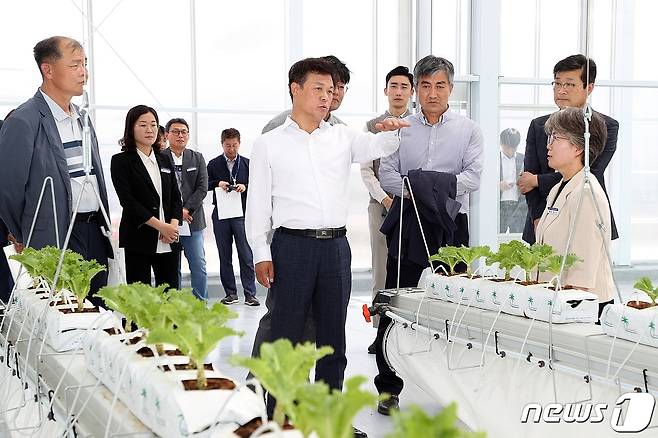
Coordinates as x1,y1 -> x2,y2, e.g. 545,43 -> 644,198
498,128 -> 528,233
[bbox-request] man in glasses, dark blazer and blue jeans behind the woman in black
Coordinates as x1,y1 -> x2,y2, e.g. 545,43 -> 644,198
164,118 -> 208,300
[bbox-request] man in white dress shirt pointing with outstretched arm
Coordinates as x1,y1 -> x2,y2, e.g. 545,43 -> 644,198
246,58 -> 408,400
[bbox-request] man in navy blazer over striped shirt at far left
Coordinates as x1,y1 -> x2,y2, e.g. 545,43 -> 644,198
0,36 -> 112,302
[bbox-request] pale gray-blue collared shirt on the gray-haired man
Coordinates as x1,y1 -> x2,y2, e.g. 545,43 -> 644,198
379,109 -> 484,213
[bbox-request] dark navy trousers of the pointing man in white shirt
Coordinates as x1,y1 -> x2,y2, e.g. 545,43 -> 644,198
268,230 -> 352,389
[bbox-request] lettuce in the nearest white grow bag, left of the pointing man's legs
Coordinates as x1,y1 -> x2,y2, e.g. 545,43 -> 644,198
146,293 -> 243,389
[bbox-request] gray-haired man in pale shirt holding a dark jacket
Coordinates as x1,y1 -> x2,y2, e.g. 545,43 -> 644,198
375,55 -> 483,415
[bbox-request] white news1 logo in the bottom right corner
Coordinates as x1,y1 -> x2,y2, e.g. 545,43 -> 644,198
521,392 -> 656,433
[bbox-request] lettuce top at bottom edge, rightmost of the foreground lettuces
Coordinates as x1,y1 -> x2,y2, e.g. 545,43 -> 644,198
386,403 -> 486,438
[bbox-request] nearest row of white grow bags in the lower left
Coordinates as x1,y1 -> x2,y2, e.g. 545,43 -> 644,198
84,331 -> 265,438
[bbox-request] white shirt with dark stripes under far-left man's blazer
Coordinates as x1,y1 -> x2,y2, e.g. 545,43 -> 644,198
41,91 -> 100,213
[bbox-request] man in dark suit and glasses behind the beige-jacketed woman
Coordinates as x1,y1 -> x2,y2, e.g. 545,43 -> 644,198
518,55 -> 619,244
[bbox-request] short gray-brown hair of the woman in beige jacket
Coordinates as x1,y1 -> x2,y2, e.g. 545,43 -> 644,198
544,107 -> 608,163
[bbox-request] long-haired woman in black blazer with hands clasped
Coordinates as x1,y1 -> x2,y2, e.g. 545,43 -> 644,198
111,105 -> 183,287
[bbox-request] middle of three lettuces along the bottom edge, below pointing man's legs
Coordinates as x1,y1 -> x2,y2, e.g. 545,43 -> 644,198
294,376 -> 377,438
